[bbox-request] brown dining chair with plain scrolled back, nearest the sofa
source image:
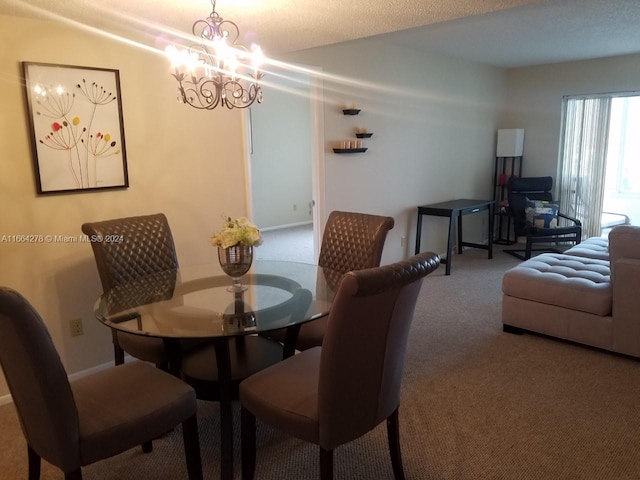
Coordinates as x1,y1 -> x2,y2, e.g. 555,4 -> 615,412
240,249 -> 440,480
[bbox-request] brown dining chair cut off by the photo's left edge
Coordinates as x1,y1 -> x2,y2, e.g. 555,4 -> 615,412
0,287 -> 202,480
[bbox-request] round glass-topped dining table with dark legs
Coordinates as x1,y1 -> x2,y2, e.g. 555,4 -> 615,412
94,260 -> 342,480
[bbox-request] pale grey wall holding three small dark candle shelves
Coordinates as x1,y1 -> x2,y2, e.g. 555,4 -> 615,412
284,39 -> 506,263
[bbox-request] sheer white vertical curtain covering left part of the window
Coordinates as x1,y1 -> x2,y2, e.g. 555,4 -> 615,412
559,96 -> 611,238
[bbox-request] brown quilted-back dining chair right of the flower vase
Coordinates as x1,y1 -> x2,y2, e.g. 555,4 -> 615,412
277,210 -> 394,350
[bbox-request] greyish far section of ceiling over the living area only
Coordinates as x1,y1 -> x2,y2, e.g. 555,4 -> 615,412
385,0 -> 640,68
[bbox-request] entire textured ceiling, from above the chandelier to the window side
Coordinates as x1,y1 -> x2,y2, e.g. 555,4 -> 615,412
0,0 -> 640,67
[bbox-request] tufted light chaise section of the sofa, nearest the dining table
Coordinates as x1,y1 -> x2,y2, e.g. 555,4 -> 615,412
502,253 -> 612,316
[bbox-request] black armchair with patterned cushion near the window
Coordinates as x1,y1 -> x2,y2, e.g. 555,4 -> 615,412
504,177 -> 582,260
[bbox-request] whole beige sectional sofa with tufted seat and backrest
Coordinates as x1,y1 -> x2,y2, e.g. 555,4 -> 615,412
502,225 -> 640,357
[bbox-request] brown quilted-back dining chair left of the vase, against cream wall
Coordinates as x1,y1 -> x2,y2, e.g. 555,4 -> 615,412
82,213 -> 178,370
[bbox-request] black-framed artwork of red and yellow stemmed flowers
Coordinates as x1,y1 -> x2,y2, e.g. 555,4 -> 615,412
22,62 -> 129,194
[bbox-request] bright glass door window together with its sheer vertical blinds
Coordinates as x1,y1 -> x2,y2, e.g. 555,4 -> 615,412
559,94 -> 640,237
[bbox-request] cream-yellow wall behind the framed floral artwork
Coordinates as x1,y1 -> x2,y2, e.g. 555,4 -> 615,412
0,15 -> 246,396
